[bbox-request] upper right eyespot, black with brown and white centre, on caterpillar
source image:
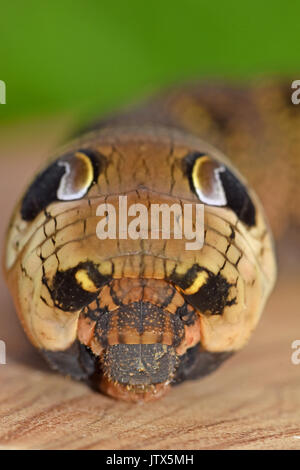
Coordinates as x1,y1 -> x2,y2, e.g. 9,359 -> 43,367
185,153 -> 255,227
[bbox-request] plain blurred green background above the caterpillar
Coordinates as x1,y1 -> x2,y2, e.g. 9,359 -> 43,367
0,0 -> 300,122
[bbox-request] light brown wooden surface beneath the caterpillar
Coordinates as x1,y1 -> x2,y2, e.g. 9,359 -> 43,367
0,119 -> 300,449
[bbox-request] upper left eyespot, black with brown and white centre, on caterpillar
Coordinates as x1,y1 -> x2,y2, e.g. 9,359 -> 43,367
21,150 -> 104,221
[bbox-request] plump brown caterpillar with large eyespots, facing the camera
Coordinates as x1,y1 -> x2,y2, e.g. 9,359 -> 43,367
5,81 -> 282,401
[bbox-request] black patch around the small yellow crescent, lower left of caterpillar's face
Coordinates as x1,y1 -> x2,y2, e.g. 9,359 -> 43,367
48,261 -> 111,312
